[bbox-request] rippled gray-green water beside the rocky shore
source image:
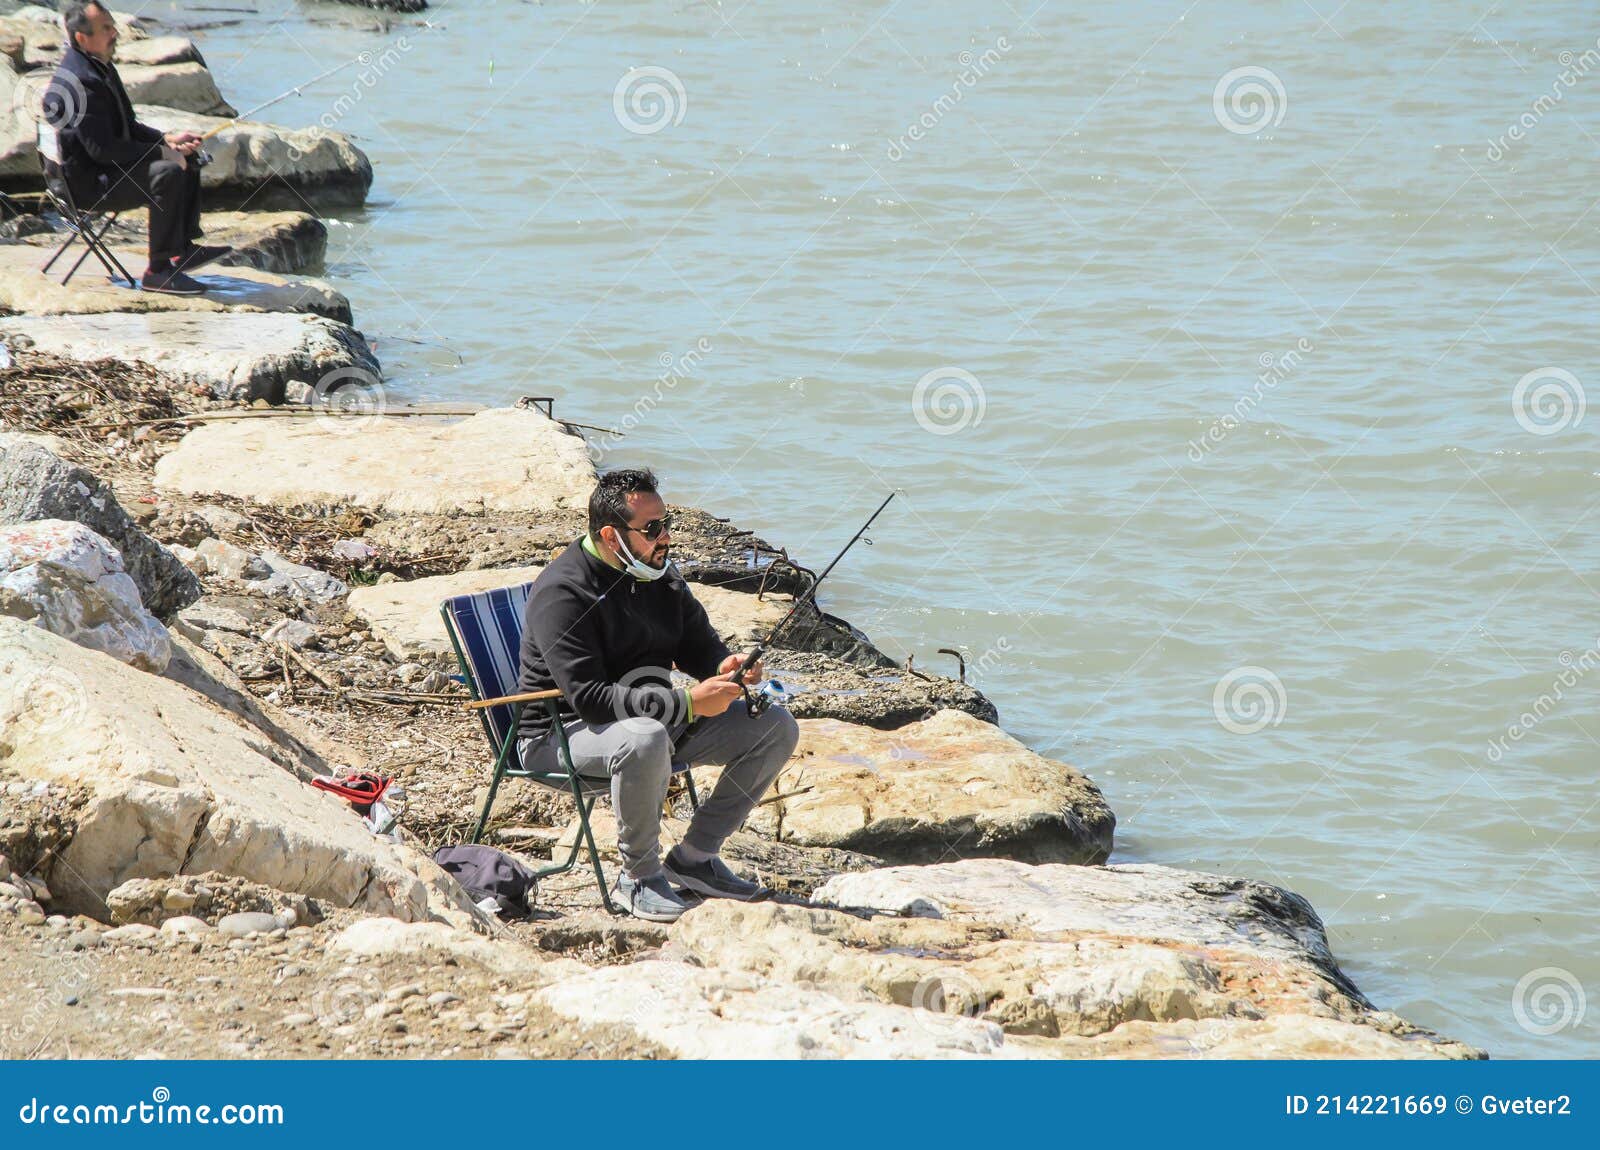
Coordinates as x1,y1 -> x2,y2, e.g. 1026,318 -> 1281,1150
175,0 -> 1600,1056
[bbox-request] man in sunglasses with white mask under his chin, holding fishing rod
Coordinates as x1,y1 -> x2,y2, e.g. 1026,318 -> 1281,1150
518,470 -> 800,923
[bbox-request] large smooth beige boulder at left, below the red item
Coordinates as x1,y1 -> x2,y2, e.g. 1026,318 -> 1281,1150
0,616 -> 444,921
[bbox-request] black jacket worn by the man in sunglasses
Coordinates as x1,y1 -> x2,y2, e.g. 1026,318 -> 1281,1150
518,541 -> 728,739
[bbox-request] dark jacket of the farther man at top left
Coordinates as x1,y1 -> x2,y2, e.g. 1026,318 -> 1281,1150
45,45 -> 162,187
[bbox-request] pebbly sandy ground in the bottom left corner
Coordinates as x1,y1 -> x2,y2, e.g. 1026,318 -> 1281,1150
0,913 -> 664,1059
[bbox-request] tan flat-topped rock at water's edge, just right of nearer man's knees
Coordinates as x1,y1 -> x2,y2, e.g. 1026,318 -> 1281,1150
732,710 -> 1117,864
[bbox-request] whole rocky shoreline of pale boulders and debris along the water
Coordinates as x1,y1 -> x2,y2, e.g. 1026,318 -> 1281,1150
0,5 -> 1482,1059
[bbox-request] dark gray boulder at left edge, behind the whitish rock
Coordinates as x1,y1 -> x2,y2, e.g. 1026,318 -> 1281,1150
0,432 -> 200,619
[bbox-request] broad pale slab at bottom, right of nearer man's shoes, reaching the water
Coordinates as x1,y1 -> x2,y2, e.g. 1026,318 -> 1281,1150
793,859 -> 1480,1059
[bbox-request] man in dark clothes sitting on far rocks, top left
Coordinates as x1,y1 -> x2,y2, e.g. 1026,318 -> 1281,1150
43,3 -> 232,296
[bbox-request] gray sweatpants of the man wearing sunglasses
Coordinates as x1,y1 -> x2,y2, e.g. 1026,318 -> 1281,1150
517,699 -> 800,878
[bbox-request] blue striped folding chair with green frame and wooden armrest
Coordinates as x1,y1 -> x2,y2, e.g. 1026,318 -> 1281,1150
438,584 -> 699,913
